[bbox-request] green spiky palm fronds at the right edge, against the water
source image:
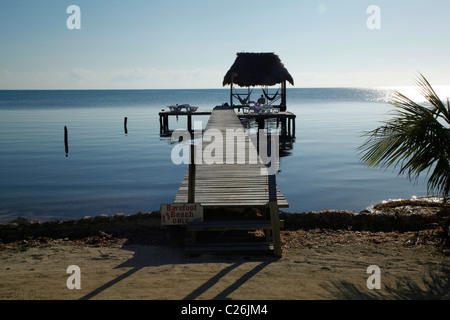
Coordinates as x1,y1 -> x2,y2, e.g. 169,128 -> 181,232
358,75 -> 450,200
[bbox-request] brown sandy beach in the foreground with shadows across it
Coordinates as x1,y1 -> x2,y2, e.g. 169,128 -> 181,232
0,225 -> 450,300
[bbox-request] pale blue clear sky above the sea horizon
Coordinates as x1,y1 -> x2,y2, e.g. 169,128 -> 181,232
0,0 -> 450,89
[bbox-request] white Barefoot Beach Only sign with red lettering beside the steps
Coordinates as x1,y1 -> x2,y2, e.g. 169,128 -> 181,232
161,203 -> 203,225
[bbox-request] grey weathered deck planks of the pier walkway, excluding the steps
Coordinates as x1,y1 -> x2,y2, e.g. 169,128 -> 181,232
174,109 -> 289,208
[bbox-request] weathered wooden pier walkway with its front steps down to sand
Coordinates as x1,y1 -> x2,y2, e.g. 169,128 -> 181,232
169,107 -> 289,257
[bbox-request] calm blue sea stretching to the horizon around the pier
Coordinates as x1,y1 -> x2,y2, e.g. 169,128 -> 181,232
0,88 -> 426,223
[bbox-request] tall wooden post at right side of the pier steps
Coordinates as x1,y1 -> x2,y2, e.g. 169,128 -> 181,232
267,135 -> 283,258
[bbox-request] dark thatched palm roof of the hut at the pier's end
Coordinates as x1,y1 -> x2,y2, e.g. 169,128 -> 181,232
222,52 -> 294,87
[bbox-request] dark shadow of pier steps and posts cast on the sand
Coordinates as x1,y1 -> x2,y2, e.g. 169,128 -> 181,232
80,245 -> 278,300
